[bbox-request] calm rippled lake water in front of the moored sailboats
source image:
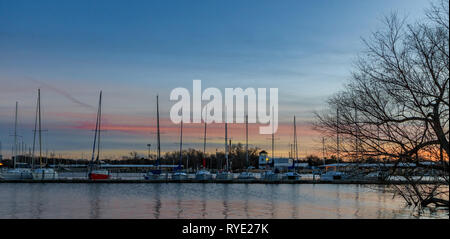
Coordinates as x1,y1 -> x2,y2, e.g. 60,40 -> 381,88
0,183 -> 449,219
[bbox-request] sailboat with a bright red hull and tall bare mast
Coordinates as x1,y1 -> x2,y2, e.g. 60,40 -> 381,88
88,91 -> 110,180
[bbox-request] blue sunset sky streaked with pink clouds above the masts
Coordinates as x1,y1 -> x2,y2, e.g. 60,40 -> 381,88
0,0 -> 430,161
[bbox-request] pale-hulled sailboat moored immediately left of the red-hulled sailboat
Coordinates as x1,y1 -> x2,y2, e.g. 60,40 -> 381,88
31,89 -> 58,180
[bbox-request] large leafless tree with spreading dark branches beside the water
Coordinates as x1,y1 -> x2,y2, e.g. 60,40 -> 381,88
316,1 -> 450,209
